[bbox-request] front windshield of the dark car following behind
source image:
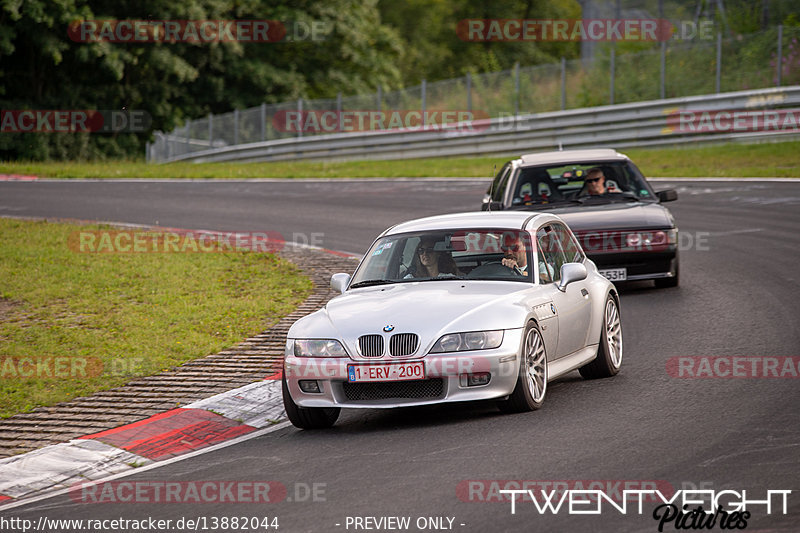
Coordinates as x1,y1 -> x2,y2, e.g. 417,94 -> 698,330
511,161 -> 656,208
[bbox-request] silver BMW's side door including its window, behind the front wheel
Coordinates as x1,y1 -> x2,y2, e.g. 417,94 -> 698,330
536,222 -> 591,359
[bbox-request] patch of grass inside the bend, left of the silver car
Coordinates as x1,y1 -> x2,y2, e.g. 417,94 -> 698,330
0,218 -> 311,418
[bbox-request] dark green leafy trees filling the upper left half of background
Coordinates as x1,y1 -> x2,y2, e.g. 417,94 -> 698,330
0,0 -> 401,159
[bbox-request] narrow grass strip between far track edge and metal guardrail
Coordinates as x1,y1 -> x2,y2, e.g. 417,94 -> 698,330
0,141 -> 800,179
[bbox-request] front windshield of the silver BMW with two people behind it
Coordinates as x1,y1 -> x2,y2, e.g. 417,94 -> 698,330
350,229 -> 532,288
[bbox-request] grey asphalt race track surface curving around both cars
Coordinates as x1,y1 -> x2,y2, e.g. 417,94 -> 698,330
0,180 -> 800,532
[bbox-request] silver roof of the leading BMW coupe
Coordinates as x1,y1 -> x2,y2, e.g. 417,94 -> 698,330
384,211 -> 558,235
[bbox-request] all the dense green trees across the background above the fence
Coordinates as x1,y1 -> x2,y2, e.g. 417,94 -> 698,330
0,0 -> 798,160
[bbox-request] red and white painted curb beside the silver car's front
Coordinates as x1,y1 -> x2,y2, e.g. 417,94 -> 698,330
0,374 -> 286,509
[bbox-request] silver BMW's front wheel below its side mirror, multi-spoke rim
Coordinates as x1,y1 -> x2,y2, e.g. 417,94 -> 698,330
498,322 -> 547,413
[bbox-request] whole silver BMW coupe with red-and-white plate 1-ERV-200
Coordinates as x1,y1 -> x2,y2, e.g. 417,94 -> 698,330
283,211 -> 622,429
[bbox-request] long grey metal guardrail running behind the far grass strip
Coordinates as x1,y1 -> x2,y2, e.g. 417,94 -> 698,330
152,85 -> 800,162
